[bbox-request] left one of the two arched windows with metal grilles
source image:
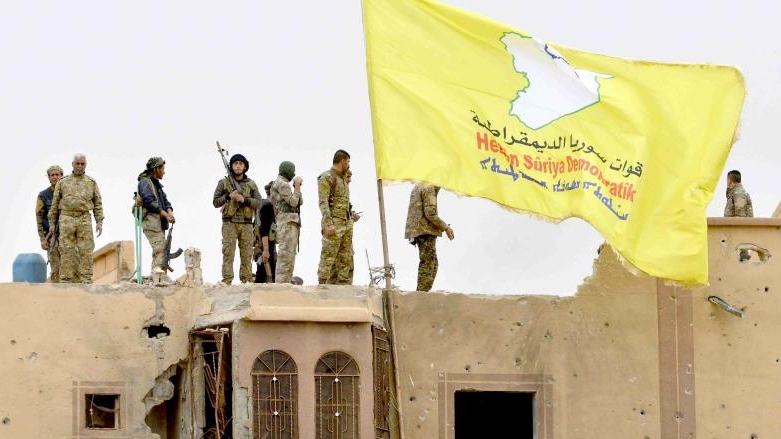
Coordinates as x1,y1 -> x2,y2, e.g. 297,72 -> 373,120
252,350 -> 298,439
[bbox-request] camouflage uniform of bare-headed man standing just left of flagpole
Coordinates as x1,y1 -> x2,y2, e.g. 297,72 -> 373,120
317,169 -> 353,284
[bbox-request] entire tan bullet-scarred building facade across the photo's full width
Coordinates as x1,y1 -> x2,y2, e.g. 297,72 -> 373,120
0,218 -> 781,439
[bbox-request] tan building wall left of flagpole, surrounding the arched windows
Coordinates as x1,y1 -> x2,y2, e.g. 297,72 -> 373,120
0,283 -> 382,439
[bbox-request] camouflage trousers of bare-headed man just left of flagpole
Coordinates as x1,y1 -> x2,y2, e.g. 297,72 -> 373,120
317,220 -> 353,285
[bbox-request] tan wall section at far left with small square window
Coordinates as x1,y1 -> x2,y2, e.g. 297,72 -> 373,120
0,284 -> 208,439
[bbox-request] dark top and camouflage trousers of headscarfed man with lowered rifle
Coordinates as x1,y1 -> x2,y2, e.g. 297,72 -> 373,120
138,172 -> 173,272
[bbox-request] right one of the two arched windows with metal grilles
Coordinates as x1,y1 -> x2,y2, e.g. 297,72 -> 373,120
315,351 -> 361,439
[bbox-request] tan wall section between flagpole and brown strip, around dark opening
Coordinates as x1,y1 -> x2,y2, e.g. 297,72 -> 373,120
392,249 -> 659,439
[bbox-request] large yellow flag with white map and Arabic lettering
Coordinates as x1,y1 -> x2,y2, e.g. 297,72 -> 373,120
363,0 -> 745,285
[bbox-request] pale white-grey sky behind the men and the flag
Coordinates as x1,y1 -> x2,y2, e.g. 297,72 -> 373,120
0,0 -> 781,295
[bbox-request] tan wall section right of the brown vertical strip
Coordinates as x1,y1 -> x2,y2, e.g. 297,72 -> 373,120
691,218 -> 781,439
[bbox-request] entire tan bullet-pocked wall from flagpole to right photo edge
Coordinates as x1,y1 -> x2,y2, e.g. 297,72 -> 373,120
391,218 -> 781,439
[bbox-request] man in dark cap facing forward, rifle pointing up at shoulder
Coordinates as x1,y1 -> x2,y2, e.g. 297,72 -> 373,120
213,154 -> 261,285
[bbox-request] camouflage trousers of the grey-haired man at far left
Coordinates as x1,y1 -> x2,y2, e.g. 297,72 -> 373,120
58,213 -> 95,284
